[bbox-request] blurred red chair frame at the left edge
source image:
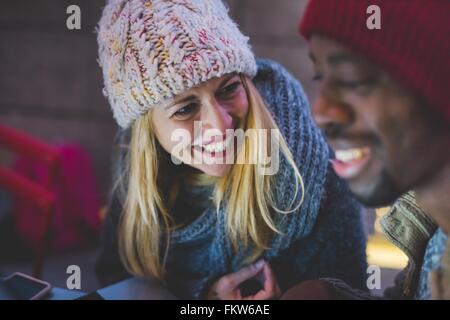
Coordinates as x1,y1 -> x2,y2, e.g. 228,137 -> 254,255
0,126 -> 60,278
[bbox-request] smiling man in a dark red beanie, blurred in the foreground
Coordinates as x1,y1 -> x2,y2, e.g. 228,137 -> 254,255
284,0 -> 450,299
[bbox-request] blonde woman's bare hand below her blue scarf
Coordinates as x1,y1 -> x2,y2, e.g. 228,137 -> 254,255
206,260 -> 281,300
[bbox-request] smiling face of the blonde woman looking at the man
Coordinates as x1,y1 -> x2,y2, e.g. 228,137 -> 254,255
152,74 -> 249,176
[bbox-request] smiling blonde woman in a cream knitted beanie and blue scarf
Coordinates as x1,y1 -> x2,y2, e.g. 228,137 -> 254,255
97,0 -> 366,299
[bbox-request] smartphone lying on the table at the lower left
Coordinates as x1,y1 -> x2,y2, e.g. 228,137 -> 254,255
0,272 -> 52,300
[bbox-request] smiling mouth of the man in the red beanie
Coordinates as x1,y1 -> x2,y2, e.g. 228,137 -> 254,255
332,147 -> 370,180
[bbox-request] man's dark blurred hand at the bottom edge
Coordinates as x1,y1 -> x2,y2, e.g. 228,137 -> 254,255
280,280 -> 334,300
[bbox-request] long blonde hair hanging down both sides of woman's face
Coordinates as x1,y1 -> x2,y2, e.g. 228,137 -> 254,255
119,76 -> 304,279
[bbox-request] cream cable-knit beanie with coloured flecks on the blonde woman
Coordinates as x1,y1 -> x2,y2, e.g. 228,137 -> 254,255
97,0 -> 256,128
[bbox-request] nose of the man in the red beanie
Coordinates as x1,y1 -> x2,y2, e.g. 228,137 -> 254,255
312,95 -> 353,137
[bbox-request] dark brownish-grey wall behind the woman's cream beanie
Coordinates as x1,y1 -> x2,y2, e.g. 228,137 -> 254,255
0,0 -> 314,202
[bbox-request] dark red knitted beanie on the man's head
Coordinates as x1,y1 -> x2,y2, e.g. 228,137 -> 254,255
300,0 -> 450,122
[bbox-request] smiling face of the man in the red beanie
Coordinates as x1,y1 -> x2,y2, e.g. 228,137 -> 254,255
310,36 -> 450,206
